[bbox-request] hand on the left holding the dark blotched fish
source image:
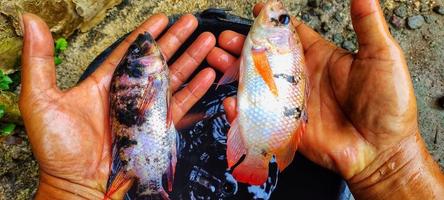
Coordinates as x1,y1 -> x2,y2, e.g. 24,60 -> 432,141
19,14 -> 216,199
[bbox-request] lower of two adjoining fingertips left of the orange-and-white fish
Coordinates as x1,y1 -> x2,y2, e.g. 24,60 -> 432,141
207,47 -> 237,72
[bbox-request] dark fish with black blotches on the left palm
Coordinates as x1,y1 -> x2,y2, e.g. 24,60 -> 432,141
105,33 -> 176,199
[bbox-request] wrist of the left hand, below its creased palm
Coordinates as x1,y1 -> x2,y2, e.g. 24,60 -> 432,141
36,171 -> 104,200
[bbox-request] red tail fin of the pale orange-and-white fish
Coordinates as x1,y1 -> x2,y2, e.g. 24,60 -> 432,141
233,154 -> 270,185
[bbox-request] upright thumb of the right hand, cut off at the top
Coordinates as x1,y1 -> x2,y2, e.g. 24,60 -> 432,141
351,0 -> 393,54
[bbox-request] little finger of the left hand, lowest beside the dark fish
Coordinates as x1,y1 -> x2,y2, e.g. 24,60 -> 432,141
171,68 -> 216,124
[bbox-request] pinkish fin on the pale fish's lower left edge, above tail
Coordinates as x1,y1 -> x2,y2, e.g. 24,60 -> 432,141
227,118 -> 247,168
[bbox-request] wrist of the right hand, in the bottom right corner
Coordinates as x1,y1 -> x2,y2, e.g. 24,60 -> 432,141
348,133 -> 444,199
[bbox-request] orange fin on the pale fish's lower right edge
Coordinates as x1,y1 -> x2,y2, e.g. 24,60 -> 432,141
275,120 -> 305,172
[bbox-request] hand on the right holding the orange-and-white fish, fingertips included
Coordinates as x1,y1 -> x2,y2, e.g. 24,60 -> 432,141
207,0 -> 444,198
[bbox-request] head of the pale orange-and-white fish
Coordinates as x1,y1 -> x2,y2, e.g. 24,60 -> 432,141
251,0 -> 296,52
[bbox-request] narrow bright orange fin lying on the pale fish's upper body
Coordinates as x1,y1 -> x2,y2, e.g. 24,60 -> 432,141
251,50 -> 278,96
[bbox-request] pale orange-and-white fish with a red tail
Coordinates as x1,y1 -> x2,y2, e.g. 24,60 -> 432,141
219,0 -> 308,185
